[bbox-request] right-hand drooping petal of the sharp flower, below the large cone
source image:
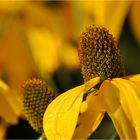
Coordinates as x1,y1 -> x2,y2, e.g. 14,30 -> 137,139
100,78 -> 140,139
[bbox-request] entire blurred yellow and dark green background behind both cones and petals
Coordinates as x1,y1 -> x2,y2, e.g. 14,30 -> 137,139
0,0 -> 140,139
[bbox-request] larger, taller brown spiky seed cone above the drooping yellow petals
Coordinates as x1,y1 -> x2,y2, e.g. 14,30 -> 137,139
78,25 -> 124,82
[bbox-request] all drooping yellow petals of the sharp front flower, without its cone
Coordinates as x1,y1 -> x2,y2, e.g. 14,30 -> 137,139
43,75 -> 140,140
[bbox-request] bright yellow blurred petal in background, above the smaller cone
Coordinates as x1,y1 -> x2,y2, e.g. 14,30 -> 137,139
27,28 -> 61,77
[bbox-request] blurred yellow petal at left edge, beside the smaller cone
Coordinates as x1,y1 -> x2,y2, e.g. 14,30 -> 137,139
0,81 -> 21,124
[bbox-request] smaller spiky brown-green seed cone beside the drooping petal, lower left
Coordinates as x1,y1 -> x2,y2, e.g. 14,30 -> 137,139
23,78 -> 57,132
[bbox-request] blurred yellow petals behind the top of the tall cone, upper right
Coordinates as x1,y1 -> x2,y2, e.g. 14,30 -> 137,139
72,1 -> 140,44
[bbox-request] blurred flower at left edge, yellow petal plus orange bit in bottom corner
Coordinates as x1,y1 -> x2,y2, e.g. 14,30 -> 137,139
0,80 -> 21,139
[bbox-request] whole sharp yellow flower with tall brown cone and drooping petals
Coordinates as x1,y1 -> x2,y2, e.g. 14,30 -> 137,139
43,25 -> 140,140
